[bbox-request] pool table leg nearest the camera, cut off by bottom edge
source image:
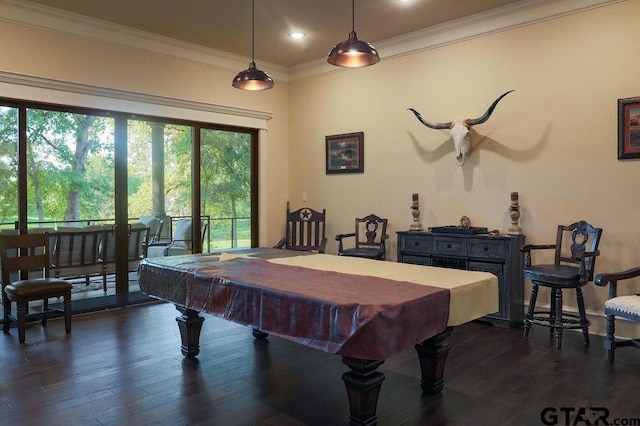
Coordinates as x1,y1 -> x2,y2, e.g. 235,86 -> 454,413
342,357 -> 384,426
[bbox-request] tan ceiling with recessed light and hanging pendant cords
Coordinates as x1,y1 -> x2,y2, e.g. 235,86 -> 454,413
30,0 -> 519,67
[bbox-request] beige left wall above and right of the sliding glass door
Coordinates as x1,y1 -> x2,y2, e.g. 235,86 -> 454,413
0,20 -> 288,248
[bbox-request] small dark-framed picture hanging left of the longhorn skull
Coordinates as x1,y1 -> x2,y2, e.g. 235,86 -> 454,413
325,132 -> 364,174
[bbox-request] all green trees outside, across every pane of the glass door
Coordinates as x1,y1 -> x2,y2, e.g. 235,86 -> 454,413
0,103 -> 251,246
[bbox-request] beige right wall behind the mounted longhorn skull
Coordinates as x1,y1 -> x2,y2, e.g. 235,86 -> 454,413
289,1 -> 640,330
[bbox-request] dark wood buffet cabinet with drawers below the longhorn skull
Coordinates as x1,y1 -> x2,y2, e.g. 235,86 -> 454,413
397,231 -> 524,328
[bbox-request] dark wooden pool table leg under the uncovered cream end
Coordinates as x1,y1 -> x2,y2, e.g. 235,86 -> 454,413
416,327 -> 453,395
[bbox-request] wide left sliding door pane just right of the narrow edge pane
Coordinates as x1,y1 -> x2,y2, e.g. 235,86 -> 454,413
26,107 -> 116,311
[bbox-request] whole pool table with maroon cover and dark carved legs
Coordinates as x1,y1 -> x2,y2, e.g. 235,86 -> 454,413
138,248 -> 498,425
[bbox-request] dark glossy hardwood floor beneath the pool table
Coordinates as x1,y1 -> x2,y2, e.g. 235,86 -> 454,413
0,304 -> 640,426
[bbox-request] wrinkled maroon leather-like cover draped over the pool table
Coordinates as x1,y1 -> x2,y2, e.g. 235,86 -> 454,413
139,249 -> 449,360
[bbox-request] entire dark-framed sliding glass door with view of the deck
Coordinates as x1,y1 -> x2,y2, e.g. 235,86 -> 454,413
0,99 -> 258,318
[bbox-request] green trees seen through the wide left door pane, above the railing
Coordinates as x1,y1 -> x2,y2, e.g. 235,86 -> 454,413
27,109 -> 113,221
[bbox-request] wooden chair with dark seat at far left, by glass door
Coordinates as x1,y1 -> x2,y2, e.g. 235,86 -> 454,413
0,232 -> 72,343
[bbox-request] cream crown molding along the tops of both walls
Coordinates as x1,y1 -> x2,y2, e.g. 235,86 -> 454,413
0,0 -> 626,84
